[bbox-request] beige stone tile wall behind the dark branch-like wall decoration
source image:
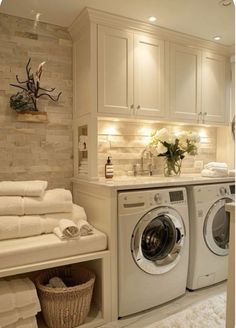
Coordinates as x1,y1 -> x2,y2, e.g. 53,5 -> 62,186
0,14 -> 73,188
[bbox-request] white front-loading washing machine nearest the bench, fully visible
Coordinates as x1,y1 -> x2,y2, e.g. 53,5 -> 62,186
118,187 -> 189,317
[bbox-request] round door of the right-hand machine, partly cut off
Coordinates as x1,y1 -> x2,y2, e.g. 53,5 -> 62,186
203,198 -> 232,256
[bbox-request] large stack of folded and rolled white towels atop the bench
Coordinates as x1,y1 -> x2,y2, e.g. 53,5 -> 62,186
0,181 -> 93,240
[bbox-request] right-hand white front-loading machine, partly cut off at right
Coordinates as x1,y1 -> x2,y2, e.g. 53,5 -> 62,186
187,183 -> 235,290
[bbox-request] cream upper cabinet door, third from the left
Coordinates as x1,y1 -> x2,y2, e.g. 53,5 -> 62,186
170,44 -> 201,122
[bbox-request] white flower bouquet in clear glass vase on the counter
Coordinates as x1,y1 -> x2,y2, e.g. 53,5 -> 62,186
148,128 -> 200,176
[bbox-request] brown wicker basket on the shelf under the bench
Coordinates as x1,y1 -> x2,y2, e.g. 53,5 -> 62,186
35,267 -> 95,328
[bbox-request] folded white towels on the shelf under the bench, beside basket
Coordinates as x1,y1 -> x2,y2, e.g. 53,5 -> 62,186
0,278 -> 41,328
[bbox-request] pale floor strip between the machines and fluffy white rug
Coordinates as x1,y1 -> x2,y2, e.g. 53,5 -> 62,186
100,282 -> 226,328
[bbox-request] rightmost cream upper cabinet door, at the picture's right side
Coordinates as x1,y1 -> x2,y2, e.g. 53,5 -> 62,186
202,53 -> 227,123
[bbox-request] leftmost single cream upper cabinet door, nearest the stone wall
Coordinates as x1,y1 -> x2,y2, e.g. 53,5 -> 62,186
98,26 -> 133,115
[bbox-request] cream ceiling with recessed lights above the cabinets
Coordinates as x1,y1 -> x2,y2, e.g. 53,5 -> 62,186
0,0 -> 235,46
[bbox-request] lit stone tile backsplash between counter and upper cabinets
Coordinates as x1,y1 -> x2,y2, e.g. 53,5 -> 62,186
98,120 -> 217,177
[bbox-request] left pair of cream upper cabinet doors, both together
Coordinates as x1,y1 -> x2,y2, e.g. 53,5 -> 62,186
98,26 -> 164,118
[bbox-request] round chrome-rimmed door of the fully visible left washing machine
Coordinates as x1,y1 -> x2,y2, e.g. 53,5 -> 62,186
131,207 -> 185,274
